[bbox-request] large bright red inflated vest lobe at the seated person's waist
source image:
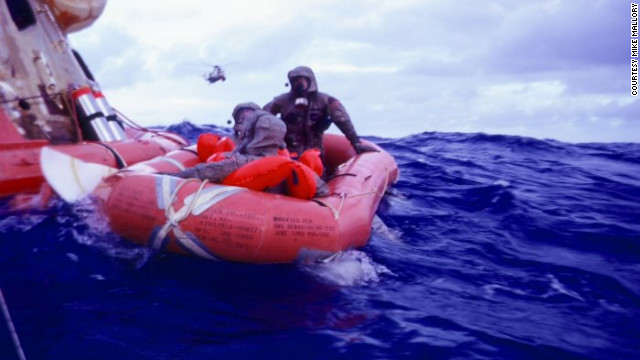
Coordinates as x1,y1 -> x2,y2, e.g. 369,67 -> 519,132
222,156 -> 317,199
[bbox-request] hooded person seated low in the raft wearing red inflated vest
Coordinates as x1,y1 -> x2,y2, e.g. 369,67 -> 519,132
164,103 -> 329,199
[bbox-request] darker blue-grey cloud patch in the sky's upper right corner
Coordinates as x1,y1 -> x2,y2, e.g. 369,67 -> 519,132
484,1 -> 629,73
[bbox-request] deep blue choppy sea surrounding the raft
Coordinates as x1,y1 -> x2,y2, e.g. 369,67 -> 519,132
0,122 -> 640,360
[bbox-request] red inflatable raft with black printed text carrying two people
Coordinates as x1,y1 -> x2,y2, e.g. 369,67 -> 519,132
93,135 -> 398,263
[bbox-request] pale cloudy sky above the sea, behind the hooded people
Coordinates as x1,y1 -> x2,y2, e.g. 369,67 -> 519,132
70,0 -> 640,142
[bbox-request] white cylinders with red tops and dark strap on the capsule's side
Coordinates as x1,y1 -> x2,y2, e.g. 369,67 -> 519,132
71,87 -> 117,141
